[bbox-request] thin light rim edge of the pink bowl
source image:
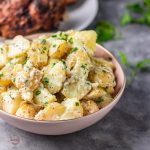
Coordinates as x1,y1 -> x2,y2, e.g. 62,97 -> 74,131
0,44 -> 126,124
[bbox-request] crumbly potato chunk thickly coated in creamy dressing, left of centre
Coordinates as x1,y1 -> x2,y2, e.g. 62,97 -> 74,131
12,63 -> 42,102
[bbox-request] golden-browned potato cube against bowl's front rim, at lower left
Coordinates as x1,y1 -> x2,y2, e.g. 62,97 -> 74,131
16,101 -> 41,119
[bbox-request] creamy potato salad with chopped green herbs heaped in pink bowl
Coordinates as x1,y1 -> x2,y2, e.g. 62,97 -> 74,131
0,30 -> 116,120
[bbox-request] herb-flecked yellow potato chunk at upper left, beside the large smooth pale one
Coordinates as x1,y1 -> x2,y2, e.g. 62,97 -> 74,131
28,38 -> 50,68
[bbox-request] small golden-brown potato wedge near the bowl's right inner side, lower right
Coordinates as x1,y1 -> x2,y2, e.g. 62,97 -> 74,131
84,87 -> 107,100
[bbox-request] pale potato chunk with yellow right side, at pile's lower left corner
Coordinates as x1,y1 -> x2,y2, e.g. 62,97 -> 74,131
1,88 -> 22,114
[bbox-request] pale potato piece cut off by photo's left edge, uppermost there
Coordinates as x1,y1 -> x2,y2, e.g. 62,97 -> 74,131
0,43 -> 8,69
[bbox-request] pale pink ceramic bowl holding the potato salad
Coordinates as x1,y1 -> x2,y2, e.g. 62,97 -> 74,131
0,45 -> 126,135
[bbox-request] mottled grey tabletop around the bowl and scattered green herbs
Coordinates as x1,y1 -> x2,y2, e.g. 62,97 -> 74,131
0,0 -> 150,150
